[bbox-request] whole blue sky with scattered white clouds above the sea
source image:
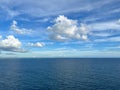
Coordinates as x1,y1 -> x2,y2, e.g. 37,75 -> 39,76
0,0 -> 120,58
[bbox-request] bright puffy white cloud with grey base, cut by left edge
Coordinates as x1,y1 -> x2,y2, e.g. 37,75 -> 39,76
0,35 -> 25,52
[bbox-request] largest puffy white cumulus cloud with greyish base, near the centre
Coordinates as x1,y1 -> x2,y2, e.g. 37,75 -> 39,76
48,15 -> 89,41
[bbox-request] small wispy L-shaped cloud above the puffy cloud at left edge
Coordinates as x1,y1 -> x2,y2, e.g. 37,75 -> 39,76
10,20 -> 32,34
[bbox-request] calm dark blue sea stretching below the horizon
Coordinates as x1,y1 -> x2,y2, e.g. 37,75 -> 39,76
0,58 -> 120,90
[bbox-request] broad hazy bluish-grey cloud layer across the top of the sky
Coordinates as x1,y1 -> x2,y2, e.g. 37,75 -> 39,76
0,0 -> 117,17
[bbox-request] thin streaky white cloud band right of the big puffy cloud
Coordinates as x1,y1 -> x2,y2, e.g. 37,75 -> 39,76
84,20 -> 120,41
